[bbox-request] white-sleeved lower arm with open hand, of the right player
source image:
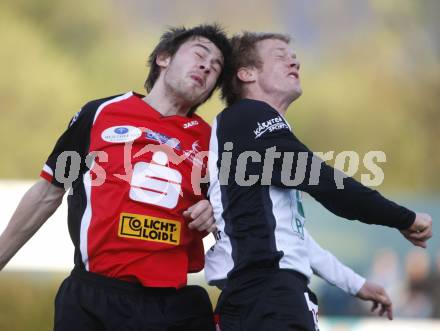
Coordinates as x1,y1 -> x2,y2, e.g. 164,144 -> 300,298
304,229 -> 393,320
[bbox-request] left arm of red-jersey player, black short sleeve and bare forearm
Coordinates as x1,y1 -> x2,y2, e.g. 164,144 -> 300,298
0,99 -> 105,269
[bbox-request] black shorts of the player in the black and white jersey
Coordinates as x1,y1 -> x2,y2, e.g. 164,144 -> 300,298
215,269 -> 318,331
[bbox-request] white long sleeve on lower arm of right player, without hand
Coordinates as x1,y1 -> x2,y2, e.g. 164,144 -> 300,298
304,229 -> 365,295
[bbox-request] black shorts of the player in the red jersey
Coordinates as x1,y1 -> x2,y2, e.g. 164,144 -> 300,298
54,270 -> 215,331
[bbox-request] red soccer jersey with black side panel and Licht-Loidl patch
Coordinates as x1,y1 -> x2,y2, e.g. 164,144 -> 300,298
41,92 -> 210,288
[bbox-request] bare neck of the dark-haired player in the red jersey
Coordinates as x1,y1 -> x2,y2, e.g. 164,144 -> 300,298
142,88 -> 191,117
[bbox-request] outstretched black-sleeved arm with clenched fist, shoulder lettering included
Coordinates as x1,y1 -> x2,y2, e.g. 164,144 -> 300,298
237,102 -> 432,247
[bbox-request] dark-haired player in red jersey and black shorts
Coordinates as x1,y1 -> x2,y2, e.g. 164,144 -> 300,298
0,25 -> 229,331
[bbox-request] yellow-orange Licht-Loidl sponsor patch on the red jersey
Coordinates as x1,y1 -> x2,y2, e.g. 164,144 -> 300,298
118,213 -> 181,245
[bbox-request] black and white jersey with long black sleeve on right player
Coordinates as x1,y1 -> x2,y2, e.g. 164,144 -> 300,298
205,99 -> 415,283
